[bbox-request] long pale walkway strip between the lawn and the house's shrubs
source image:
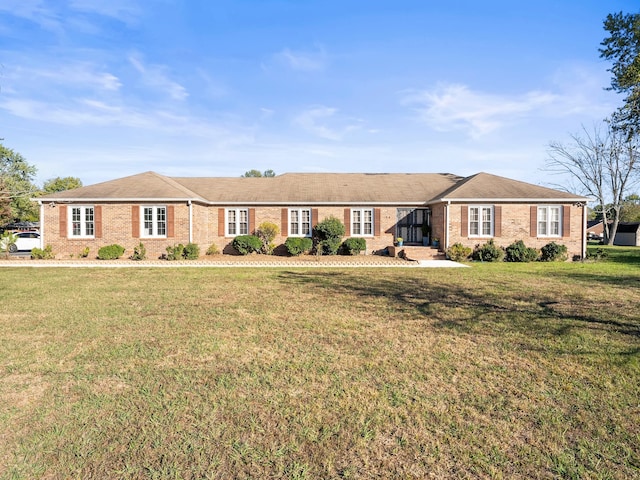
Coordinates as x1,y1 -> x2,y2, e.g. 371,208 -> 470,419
0,255 -> 468,268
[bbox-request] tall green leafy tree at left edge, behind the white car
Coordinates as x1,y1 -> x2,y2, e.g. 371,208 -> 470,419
0,144 -> 38,223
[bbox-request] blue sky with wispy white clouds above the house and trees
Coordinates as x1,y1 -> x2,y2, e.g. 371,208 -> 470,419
0,0 -> 638,185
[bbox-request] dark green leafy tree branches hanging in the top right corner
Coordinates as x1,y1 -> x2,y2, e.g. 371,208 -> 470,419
599,12 -> 640,135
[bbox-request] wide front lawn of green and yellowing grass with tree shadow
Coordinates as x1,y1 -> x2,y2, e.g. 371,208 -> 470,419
0,249 -> 640,479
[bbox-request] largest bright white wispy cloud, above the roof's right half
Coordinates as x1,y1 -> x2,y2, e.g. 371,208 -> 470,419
402,84 -> 559,138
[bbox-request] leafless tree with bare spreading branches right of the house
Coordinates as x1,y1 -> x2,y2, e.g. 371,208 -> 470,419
546,120 -> 640,245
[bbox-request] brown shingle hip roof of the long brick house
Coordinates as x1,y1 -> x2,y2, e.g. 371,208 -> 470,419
39,172 -> 584,205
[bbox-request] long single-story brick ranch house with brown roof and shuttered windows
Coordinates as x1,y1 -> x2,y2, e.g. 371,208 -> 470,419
36,172 -> 587,258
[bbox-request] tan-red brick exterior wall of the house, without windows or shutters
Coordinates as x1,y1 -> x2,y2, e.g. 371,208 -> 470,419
41,203 -> 583,259
